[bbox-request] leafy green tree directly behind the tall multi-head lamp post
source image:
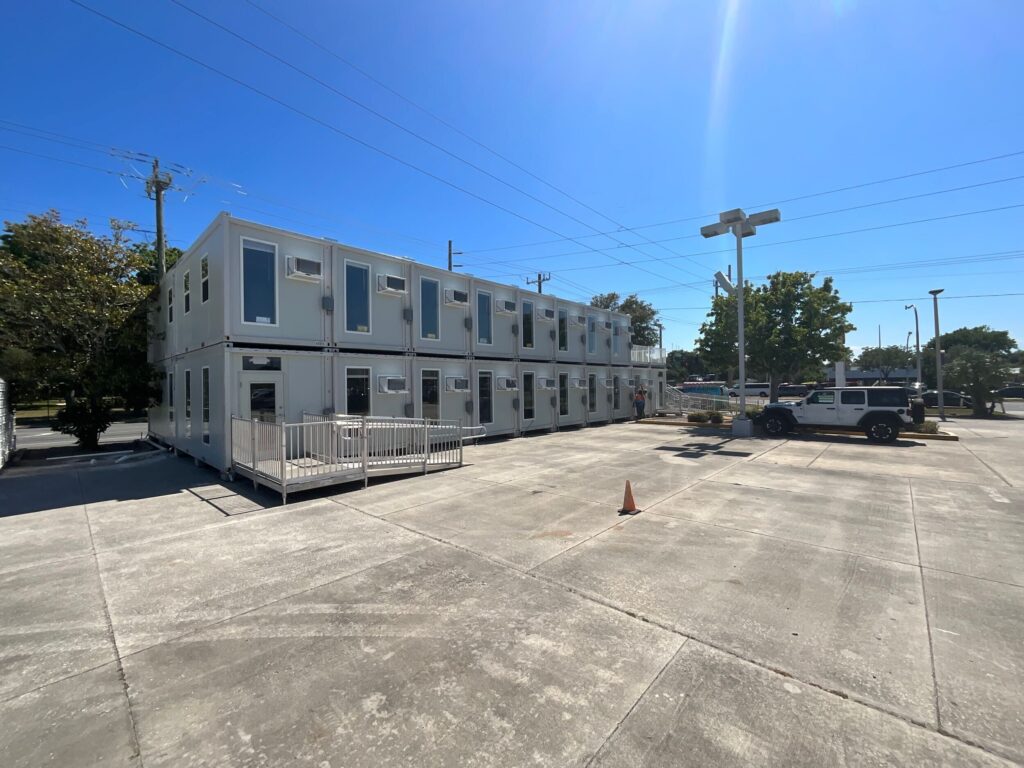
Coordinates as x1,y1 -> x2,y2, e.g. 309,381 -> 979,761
697,272 -> 854,401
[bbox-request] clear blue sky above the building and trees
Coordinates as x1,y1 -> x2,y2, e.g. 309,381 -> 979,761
0,0 -> 1024,348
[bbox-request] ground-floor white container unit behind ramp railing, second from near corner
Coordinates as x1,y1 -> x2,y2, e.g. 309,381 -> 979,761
332,351 -> 415,418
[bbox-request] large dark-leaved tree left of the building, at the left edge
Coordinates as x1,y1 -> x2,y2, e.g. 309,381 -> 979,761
0,211 -> 155,447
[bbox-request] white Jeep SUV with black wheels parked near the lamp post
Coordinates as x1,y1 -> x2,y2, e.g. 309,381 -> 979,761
756,387 -> 913,442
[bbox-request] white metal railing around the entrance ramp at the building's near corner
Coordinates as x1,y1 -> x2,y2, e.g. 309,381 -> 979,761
231,413 -> 464,502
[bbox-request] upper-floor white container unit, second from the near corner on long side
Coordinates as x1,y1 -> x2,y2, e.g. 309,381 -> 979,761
330,246 -> 416,352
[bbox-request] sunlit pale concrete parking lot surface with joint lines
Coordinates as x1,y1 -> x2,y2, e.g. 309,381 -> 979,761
0,420 -> 1024,768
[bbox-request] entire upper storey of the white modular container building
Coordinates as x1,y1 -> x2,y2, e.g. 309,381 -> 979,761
151,213 -> 636,366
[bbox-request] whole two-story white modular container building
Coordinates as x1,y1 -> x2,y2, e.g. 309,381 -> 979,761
150,213 -> 665,469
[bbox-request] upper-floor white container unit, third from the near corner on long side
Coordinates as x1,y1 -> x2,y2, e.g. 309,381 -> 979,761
411,264 -> 473,355
